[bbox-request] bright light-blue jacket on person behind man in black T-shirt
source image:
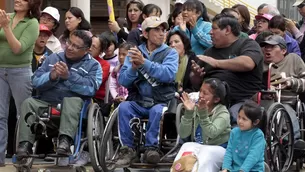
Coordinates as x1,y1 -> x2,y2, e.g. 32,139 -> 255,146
174,17 -> 212,55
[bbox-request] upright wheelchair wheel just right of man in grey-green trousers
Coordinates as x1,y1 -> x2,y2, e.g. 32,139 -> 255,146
87,103 -> 104,171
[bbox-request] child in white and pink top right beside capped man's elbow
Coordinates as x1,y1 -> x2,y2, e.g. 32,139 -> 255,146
109,42 -> 133,104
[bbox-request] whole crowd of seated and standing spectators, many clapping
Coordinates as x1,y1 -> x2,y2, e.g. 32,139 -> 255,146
0,0 -> 305,172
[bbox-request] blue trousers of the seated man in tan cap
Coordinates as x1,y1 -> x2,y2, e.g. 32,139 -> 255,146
118,101 -> 165,148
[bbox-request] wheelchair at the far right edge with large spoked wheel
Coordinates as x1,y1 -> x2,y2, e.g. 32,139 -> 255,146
257,63 -> 305,172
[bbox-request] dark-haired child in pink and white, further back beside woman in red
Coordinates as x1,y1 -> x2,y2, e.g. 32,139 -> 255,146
100,31 -> 119,73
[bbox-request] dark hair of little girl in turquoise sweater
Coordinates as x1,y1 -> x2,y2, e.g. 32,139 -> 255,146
238,100 -> 267,132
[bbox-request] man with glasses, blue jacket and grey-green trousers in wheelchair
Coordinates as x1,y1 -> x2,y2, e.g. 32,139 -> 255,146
17,30 -> 102,157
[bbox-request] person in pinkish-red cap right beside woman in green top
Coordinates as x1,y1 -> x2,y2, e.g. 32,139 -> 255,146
32,24 -> 53,72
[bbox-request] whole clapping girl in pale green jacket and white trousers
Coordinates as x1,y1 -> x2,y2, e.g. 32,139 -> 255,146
172,78 -> 231,172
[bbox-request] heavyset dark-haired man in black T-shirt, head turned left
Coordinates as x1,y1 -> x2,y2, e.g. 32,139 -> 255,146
191,14 -> 263,123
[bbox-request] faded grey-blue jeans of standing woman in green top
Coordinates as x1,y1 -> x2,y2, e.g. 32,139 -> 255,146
0,67 -> 32,164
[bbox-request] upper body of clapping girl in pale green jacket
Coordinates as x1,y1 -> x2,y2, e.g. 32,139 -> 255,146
178,78 -> 231,147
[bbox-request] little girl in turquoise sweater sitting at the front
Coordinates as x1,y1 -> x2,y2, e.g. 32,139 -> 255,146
222,100 -> 266,172
